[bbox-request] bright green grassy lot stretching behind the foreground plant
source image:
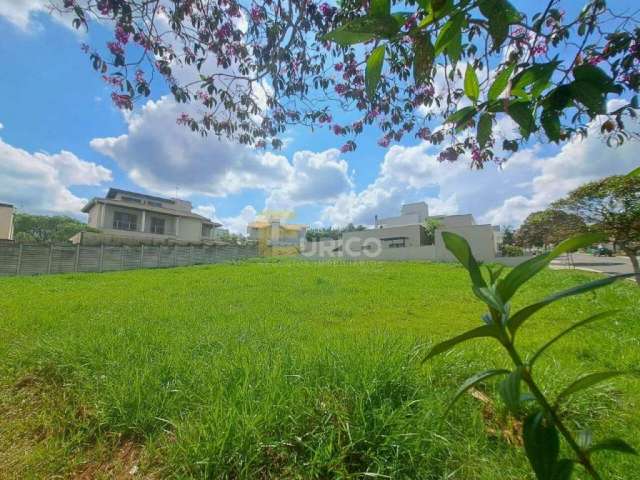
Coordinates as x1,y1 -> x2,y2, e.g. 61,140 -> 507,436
0,261 -> 640,480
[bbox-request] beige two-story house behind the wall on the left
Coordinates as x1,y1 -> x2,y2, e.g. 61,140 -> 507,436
76,188 -> 222,243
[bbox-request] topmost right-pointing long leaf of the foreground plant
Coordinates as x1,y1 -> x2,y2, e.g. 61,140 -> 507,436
498,232 -> 605,303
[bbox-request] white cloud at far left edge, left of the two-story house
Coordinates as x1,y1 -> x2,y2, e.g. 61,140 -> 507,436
0,133 -> 111,215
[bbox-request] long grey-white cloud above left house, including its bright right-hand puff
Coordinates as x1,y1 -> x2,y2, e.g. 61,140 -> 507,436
91,97 -> 352,208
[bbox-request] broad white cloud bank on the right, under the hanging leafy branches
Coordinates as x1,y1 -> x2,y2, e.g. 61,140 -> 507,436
322,109 -> 638,229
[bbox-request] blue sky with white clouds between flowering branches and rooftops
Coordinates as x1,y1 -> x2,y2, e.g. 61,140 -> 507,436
0,0 -> 637,231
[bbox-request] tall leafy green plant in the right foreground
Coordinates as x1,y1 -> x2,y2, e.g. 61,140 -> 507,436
425,232 -> 636,480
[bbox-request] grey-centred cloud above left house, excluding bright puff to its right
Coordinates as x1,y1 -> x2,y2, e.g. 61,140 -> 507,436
91,97 -> 292,196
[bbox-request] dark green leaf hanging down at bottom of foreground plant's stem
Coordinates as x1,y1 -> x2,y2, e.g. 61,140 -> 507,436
522,412 -> 560,480
